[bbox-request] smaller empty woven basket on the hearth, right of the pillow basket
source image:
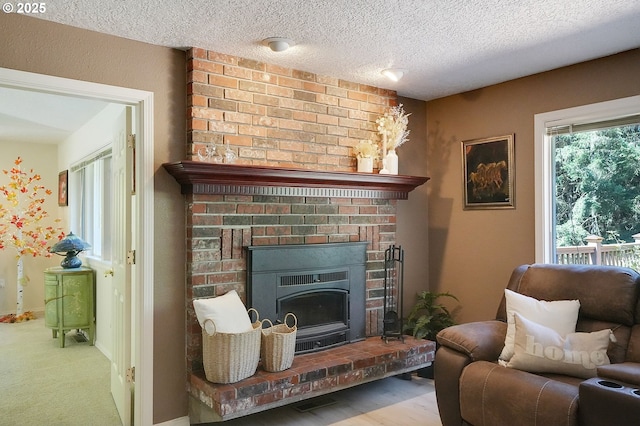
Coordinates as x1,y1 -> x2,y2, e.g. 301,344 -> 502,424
260,312 -> 298,372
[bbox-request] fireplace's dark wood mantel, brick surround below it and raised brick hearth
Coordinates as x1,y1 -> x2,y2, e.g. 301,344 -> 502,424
164,161 -> 435,423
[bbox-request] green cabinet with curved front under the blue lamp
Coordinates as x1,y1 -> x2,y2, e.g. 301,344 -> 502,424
44,266 -> 96,348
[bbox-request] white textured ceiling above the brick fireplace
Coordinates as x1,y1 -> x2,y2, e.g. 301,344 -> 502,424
28,0 -> 640,100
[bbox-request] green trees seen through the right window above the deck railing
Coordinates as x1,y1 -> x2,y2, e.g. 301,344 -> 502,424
548,120 -> 640,247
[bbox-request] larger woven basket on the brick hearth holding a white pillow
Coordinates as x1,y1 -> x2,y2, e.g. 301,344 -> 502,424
202,308 -> 262,383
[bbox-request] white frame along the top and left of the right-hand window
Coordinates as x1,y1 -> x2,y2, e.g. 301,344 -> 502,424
534,96 -> 640,263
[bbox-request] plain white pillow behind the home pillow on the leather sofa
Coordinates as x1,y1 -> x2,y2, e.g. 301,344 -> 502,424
500,289 -> 580,361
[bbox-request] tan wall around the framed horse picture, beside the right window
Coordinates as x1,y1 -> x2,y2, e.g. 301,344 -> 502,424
426,49 -> 640,322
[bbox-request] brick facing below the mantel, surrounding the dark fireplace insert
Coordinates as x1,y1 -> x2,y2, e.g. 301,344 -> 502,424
187,191 -> 396,369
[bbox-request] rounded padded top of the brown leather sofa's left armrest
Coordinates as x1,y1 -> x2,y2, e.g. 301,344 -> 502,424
436,321 -> 507,361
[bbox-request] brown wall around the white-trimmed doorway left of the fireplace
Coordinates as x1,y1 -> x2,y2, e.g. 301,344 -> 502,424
0,14 -> 187,423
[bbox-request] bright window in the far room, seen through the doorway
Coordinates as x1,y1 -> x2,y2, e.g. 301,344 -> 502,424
71,148 -> 113,261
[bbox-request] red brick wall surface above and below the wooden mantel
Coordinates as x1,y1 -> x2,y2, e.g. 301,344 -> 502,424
186,49 -> 396,370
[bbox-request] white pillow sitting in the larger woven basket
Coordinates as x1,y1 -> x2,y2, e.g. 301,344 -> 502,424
193,290 -> 253,334
